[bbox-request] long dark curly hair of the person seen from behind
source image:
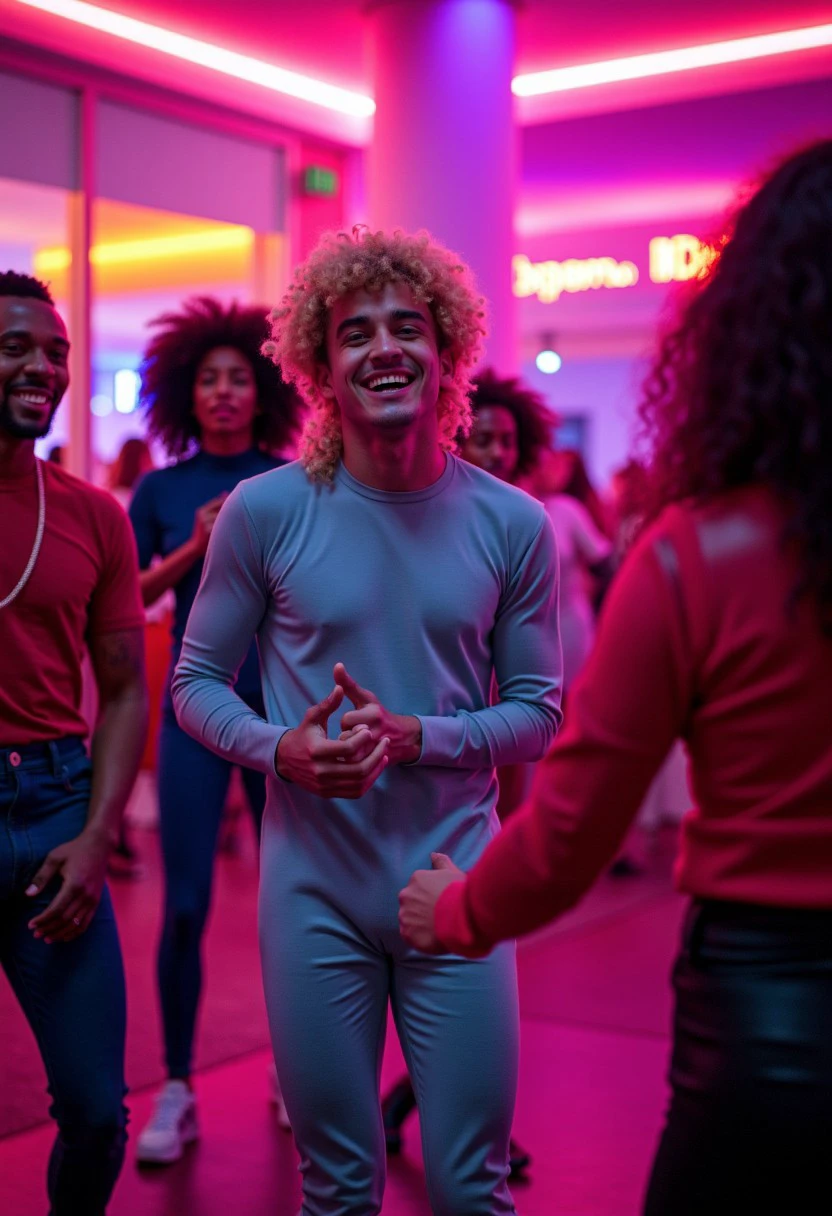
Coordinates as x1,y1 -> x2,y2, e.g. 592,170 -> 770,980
640,140 -> 832,632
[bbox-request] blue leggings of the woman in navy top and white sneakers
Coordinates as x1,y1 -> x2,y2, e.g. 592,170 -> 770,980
158,699 -> 265,1077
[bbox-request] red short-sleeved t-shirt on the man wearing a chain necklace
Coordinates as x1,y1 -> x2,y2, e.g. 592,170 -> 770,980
0,463 -> 145,747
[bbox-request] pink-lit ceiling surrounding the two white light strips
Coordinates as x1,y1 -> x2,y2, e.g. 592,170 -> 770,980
0,0 -> 832,136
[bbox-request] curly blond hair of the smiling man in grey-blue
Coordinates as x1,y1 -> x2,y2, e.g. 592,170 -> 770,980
263,227 -> 485,482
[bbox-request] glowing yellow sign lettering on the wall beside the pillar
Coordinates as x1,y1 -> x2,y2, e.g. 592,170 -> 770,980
512,232 -> 724,304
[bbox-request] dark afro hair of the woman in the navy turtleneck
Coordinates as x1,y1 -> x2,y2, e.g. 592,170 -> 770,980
139,295 -> 302,457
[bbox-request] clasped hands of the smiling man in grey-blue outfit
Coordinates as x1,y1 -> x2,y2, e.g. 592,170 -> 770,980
275,663 -> 422,798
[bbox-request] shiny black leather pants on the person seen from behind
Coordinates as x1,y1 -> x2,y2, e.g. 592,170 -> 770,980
645,902 -> 832,1216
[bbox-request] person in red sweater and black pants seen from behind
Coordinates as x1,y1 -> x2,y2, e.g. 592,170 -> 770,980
401,141 -> 832,1216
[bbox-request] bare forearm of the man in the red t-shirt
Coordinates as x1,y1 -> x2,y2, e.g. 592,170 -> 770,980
85,682 -> 147,846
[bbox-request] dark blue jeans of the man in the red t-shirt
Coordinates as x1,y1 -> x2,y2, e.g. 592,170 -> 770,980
0,739 -> 127,1216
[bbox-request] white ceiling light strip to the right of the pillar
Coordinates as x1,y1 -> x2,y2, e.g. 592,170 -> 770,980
511,24 -> 832,97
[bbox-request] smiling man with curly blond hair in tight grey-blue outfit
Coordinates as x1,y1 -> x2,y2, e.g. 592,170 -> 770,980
174,231 -> 561,1216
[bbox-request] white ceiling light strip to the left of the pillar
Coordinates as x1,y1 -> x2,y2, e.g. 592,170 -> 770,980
18,0 -> 376,118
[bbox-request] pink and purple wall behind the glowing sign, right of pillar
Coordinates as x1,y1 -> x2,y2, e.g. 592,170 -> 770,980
516,73 -> 832,484
